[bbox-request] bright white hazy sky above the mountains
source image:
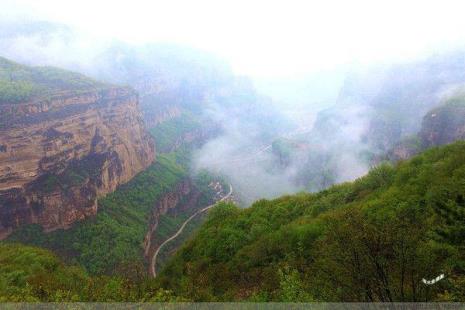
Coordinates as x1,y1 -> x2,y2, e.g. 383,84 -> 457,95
0,0 -> 465,76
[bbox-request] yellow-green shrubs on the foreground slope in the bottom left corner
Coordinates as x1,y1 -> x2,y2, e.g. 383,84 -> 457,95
0,244 -> 180,302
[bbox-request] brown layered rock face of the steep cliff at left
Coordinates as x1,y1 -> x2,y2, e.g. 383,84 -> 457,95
0,86 -> 155,238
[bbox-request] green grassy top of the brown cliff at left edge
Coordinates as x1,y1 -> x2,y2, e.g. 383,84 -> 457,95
0,57 -> 105,104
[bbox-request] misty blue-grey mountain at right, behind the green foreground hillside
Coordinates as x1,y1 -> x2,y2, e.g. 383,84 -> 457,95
276,51 -> 465,191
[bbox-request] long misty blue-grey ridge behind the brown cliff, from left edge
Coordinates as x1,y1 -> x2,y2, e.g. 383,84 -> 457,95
0,20 -> 290,140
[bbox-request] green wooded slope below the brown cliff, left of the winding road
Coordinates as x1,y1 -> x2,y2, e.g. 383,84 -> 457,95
7,148 -> 224,275
